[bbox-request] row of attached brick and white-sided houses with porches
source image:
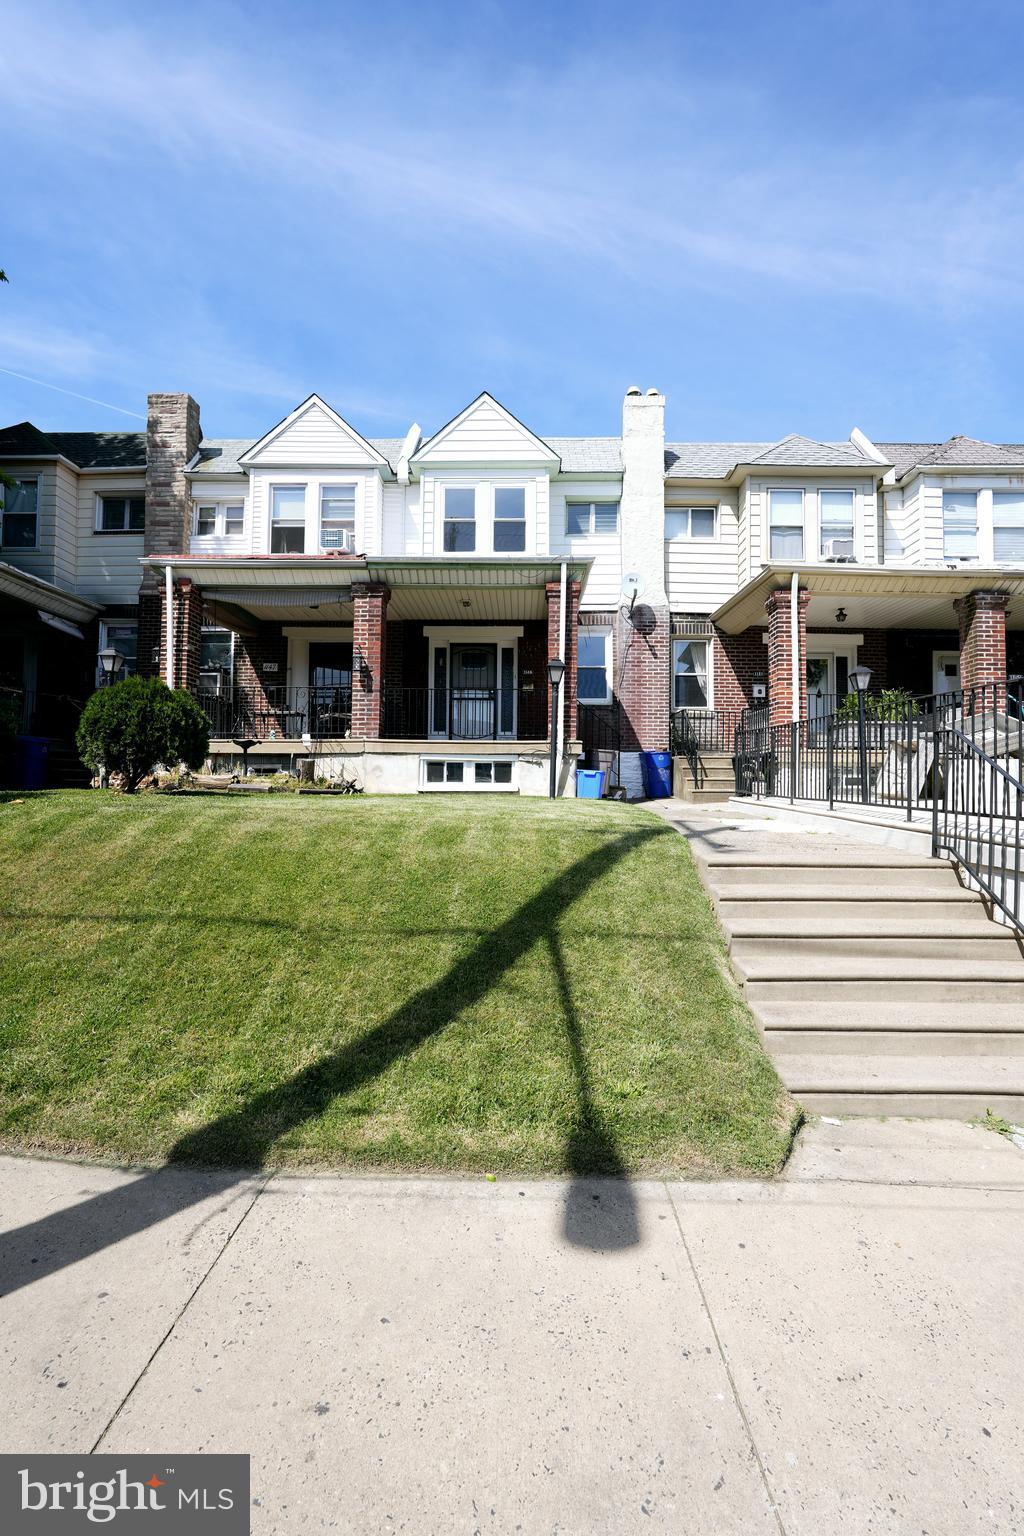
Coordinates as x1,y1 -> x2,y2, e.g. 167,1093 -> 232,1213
0,389 -> 1024,794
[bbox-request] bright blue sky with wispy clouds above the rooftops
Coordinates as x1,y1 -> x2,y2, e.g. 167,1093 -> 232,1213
0,0 -> 1024,441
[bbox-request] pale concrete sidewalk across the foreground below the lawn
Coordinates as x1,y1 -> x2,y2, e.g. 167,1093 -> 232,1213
0,1121 -> 1024,1536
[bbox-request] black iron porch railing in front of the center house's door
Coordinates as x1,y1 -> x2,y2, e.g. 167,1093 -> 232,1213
382,687 -> 548,742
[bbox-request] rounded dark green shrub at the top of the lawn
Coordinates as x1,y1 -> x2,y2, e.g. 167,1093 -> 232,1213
75,677 -> 210,794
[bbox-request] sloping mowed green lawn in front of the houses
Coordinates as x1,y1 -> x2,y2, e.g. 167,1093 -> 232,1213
0,791 -> 794,1175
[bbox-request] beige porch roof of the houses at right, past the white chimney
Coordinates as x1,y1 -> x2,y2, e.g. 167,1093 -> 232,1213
711,565 -> 1024,634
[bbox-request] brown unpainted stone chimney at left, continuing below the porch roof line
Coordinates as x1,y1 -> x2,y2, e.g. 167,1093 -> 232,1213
138,395 -> 203,677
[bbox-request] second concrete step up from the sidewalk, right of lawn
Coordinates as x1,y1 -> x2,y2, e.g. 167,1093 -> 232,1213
757,989 -> 1024,1040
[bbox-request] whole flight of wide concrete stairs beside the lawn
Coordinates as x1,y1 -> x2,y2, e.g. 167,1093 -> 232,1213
695,848 -> 1024,1120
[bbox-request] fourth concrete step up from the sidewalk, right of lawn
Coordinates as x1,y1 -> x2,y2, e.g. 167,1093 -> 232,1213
718,902 -> 1019,933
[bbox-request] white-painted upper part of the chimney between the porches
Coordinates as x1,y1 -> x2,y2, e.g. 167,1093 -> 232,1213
620,386 -> 668,608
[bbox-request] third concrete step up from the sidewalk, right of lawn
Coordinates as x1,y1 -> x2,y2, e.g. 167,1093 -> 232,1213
746,965 -> 1024,1017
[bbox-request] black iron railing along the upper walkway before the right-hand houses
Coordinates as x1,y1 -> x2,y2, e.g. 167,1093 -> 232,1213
735,677 -> 1024,820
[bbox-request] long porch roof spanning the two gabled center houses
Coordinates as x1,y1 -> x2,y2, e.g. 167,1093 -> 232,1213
143,554 -> 593,624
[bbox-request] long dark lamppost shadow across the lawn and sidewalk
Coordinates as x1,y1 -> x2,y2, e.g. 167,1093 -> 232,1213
0,826 -> 666,1295
